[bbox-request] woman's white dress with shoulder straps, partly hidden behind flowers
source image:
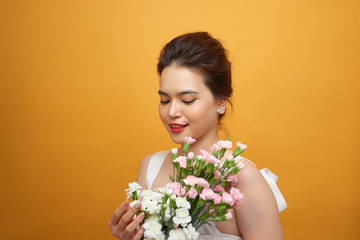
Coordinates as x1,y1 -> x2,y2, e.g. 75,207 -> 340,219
146,151 -> 287,240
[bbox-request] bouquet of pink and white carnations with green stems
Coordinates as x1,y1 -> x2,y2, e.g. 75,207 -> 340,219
125,137 -> 246,240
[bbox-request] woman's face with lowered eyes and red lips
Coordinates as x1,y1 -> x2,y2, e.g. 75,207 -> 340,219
159,64 -> 221,144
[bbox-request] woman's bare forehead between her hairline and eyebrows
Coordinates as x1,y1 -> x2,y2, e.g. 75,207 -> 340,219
160,64 -> 210,93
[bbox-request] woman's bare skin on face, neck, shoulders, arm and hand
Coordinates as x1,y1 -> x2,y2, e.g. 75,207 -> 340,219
109,64 -> 283,240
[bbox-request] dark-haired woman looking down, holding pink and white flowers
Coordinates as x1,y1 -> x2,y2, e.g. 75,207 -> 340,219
109,32 -> 286,240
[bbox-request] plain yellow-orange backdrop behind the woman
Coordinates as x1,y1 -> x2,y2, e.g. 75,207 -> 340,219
0,0 -> 360,240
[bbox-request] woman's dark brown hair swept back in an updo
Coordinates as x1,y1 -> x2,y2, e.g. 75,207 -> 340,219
157,32 -> 233,118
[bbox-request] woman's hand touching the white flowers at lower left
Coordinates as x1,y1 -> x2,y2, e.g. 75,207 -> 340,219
109,201 -> 145,240
